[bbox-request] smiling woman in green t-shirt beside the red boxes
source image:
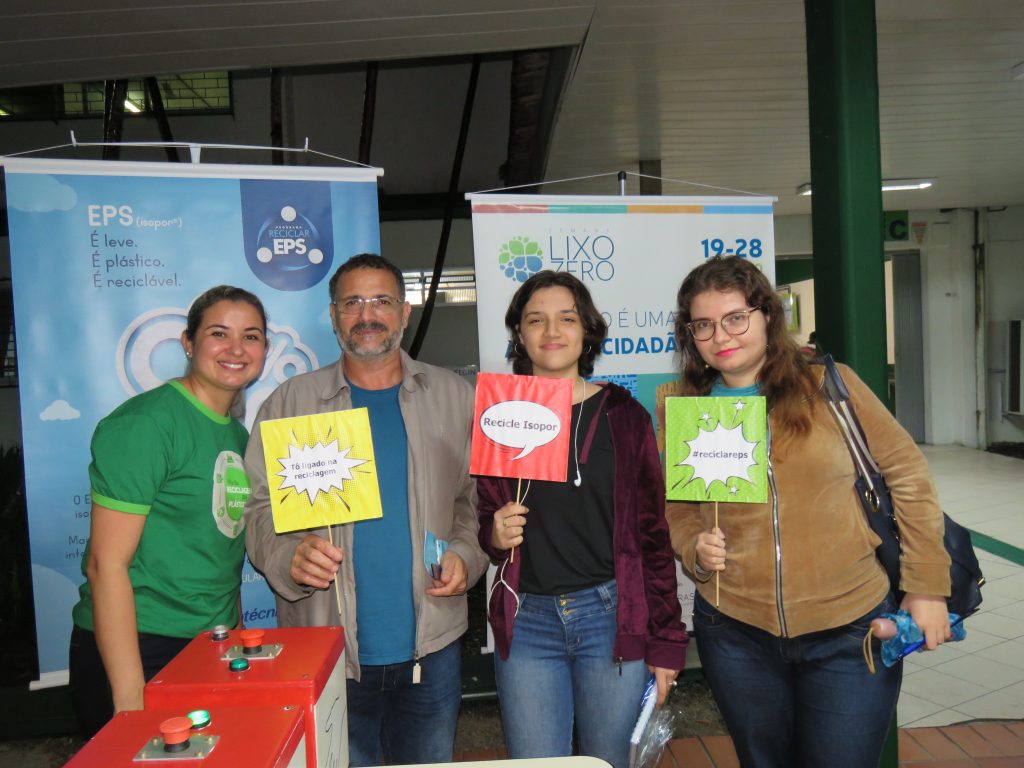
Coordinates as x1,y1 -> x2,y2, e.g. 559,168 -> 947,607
70,286 -> 267,736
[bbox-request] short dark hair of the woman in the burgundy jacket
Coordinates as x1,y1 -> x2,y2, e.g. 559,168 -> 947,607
505,269 -> 608,376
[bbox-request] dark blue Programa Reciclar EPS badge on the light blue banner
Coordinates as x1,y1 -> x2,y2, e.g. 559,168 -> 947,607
239,179 -> 334,291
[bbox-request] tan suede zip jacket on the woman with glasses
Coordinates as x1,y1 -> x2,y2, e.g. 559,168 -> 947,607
666,366 -> 949,637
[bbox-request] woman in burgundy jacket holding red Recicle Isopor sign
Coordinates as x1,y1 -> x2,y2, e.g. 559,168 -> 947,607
477,270 -> 687,768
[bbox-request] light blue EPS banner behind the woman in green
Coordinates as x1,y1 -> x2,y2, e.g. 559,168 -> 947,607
4,159 -> 382,682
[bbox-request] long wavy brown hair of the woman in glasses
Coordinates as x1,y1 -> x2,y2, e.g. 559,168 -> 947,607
676,256 -> 817,437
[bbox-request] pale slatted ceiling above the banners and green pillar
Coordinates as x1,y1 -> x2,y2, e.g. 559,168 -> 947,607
0,0 -> 1024,213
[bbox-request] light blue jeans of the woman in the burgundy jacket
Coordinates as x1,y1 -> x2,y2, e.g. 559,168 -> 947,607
495,581 -> 650,768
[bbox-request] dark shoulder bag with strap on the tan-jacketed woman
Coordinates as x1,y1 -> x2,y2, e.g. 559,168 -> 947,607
820,354 -> 985,617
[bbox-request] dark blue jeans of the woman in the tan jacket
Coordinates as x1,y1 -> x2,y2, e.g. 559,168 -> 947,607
693,593 -> 903,768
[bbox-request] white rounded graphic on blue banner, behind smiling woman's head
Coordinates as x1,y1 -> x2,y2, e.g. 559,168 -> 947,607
116,307 -> 319,427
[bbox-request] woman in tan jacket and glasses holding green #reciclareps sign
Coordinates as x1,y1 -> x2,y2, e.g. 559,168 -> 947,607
667,257 -> 949,768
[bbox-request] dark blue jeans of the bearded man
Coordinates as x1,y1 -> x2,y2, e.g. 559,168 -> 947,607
347,641 -> 462,768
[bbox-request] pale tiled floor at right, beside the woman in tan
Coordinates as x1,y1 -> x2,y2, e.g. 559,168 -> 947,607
897,445 -> 1024,729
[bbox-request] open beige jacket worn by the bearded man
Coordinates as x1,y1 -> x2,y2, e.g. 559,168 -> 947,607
246,352 -> 487,680
